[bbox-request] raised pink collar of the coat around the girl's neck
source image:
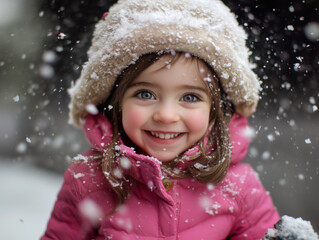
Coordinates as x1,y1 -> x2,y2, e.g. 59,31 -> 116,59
84,114 -> 249,202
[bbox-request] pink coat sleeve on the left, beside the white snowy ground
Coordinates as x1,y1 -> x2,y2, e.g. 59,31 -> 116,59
40,168 -> 95,240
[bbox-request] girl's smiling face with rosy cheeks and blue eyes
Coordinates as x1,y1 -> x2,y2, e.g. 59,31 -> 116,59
121,55 -> 211,161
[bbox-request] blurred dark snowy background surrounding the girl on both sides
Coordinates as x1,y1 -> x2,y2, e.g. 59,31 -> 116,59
0,0 -> 319,240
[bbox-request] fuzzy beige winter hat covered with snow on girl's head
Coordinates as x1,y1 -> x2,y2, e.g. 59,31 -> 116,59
69,0 -> 260,126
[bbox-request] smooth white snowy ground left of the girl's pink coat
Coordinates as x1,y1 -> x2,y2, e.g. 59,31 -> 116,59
0,159 -> 63,240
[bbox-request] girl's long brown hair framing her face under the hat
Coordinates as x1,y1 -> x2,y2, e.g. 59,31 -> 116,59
99,52 -> 233,205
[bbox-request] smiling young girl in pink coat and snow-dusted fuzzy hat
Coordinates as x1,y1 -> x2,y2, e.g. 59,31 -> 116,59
41,0 -> 279,240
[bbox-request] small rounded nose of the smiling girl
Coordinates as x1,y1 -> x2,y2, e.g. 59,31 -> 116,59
153,104 -> 180,124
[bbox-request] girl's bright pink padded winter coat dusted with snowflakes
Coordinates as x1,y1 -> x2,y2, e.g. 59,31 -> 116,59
41,115 -> 279,240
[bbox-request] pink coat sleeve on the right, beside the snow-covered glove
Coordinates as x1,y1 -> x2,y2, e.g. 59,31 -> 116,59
230,165 -> 280,240
